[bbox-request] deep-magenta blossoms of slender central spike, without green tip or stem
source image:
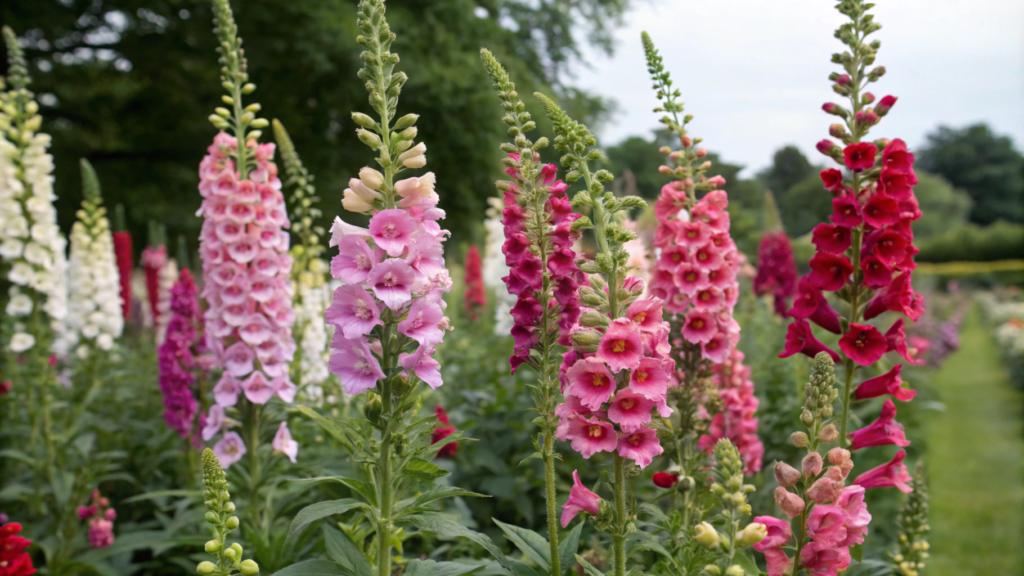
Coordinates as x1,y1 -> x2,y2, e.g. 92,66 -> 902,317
502,153 -> 584,373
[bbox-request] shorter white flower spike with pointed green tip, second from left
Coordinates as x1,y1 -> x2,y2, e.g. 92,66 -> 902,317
68,159 -> 124,359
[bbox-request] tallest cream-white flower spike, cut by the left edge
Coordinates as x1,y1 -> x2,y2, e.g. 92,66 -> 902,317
0,27 -> 70,354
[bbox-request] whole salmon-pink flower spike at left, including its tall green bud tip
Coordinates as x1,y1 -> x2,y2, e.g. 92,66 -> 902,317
198,0 -> 295,467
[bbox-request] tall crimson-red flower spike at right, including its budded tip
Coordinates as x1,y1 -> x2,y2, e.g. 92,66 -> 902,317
779,0 -> 924,487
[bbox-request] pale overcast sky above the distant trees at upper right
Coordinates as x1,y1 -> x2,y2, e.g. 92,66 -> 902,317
575,0 -> 1024,175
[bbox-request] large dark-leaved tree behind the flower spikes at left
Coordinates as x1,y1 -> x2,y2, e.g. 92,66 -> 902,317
0,0 -> 628,247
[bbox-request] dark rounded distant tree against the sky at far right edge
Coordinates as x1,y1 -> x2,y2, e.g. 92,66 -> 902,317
918,124 -> 1024,224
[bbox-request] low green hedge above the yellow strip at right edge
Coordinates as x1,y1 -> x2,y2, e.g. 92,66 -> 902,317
918,221 -> 1024,262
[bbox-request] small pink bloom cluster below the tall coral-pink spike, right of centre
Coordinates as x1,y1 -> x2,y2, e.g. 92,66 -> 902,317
697,347 -> 765,476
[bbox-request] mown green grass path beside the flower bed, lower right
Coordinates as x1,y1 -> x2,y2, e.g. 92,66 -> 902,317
925,314 -> 1024,576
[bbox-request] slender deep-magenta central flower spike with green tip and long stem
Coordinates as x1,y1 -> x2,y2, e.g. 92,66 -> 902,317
480,49 -> 585,570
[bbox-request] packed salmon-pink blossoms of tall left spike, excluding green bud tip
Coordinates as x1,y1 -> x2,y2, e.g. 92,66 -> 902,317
199,132 -> 296,466
